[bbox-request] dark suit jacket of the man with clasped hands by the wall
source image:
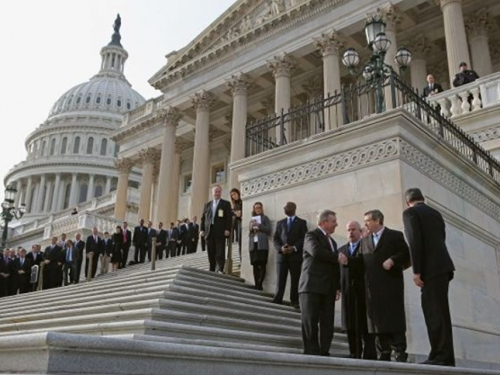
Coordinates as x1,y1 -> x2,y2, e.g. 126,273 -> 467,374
273,216 -> 307,263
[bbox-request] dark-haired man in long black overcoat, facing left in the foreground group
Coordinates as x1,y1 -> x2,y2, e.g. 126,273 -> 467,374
339,210 -> 410,362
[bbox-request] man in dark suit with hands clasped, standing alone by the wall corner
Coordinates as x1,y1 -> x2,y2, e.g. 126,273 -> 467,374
273,202 -> 307,308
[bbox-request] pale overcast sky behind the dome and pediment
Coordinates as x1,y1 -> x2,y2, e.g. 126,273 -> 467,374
0,0 -> 235,201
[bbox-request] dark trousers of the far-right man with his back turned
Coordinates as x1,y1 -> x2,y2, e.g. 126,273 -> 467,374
421,274 -> 455,366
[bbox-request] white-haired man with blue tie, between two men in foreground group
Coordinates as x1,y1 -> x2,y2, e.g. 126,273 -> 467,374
339,221 -> 377,359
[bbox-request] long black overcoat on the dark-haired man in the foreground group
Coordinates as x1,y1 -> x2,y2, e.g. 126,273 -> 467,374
361,227 -> 410,333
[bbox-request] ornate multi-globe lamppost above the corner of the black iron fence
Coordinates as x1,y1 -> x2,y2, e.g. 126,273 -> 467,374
342,14 -> 411,113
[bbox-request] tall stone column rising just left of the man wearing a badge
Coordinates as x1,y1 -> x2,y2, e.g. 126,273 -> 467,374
189,91 -> 214,217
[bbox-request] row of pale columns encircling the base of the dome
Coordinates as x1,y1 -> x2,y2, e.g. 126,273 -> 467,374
11,173 -> 112,213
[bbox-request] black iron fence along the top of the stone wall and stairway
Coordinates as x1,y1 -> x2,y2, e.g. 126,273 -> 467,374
246,73 -> 500,185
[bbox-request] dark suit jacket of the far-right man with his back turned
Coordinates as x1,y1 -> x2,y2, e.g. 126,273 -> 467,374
403,202 -> 455,281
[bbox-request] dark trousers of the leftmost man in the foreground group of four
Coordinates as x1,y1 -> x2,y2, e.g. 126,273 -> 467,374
299,291 -> 335,356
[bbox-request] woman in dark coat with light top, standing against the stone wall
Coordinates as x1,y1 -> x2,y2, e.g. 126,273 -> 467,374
248,202 -> 271,290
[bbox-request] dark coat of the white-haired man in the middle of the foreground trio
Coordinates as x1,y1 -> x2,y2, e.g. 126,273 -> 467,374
339,241 -> 366,331
